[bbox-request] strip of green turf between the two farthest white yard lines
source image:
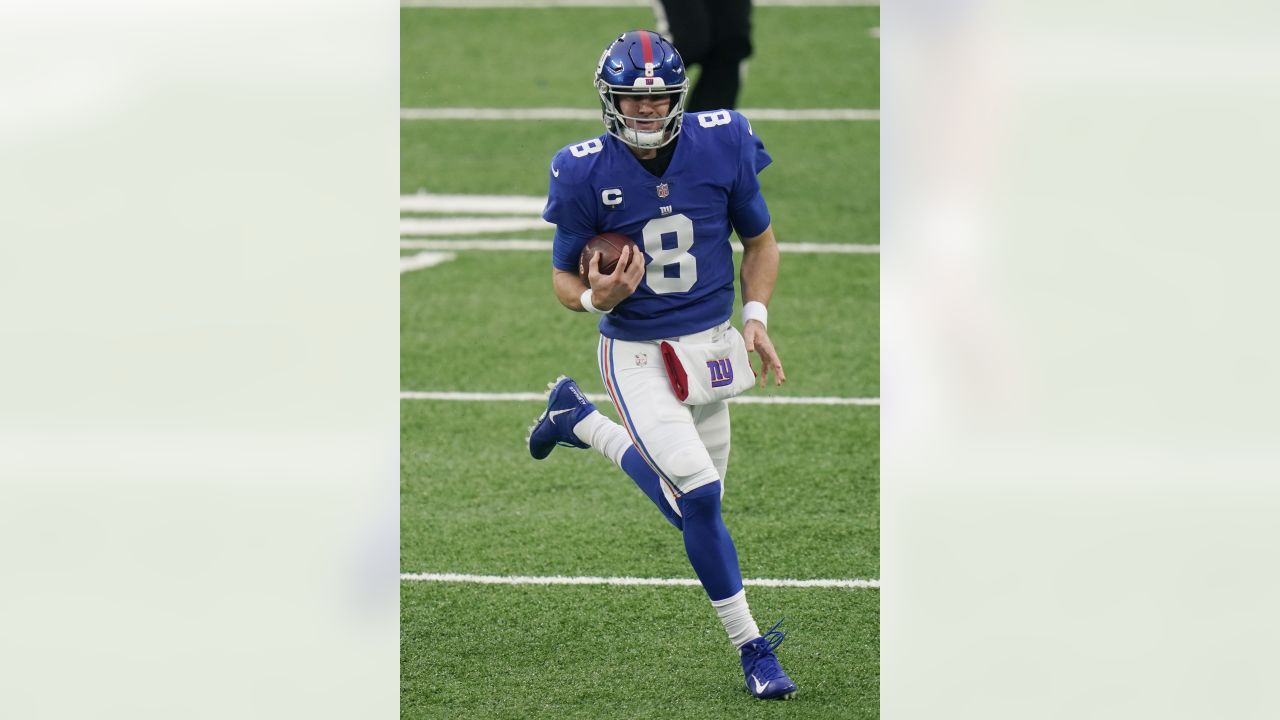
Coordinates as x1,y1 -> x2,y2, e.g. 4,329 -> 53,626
401,6 -> 879,108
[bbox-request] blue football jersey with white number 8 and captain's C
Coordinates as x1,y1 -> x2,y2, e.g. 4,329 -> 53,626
543,110 -> 773,340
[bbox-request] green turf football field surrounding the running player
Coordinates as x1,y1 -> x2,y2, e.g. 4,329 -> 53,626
401,8 -> 879,719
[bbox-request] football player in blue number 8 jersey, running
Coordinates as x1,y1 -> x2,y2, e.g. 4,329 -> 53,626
527,31 -> 796,698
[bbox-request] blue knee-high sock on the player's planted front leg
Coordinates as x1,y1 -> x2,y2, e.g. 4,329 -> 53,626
678,480 -> 742,601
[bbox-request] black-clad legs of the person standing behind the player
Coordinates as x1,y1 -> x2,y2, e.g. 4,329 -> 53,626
654,0 -> 751,113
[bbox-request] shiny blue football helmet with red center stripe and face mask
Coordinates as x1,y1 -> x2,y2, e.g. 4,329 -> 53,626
595,29 -> 689,150
